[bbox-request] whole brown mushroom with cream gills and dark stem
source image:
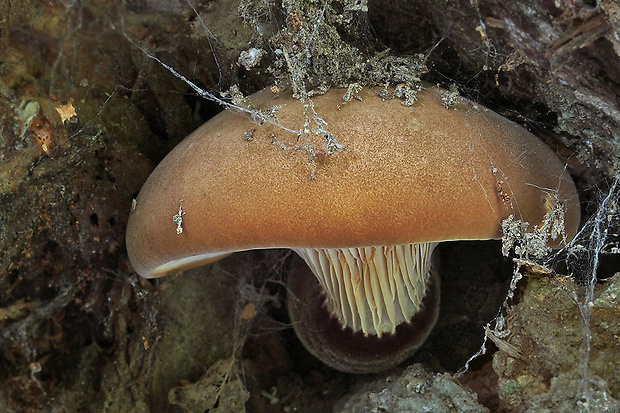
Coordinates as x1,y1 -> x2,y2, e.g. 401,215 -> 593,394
126,86 -> 580,373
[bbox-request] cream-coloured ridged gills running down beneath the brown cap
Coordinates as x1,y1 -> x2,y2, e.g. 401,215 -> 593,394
295,242 -> 437,338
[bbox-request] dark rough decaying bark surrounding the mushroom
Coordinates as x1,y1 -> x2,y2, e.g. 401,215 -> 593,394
0,0 -> 620,412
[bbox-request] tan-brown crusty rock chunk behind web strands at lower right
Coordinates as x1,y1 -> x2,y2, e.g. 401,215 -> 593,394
493,277 -> 620,407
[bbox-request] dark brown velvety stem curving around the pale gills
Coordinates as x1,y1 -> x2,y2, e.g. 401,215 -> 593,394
287,254 -> 440,373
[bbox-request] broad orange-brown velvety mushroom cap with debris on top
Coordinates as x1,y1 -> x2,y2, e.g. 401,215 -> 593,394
126,87 -> 580,277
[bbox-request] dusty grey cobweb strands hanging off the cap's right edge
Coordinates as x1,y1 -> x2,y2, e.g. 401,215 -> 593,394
457,178 -> 620,409
